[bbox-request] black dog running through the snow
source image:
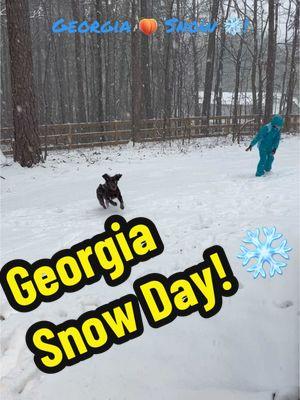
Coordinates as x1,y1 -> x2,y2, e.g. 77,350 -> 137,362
96,174 -> 124,210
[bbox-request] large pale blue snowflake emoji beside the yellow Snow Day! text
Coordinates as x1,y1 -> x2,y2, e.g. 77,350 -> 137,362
238,228 -> 292,279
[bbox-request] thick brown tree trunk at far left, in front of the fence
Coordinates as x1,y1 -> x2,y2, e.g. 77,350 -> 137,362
6,0 -> 42,167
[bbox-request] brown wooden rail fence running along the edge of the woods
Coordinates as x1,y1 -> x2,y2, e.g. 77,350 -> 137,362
0,115 -> 300,155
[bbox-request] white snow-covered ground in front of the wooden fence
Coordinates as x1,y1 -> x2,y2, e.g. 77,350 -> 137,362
0,137 -> 300,400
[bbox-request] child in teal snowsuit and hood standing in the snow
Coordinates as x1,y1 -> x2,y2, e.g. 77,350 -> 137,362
246,115 -> 284,176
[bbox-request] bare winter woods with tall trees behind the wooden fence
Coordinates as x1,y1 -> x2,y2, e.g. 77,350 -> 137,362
1,0 -> 299,166
